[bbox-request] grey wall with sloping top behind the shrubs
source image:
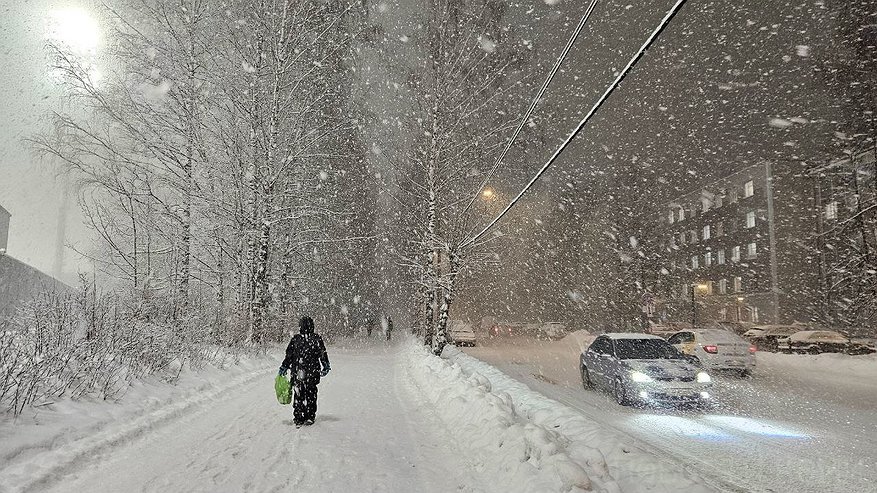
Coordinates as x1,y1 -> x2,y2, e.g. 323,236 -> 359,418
0,255 -> 73,320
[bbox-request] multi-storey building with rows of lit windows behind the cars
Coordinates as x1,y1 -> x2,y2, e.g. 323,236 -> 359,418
652,163 -> 819,324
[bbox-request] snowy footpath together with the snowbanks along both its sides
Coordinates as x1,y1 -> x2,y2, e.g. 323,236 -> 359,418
0,340 -> 714,493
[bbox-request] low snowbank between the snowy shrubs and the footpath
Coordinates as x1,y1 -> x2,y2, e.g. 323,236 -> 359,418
0,356 -> 279,493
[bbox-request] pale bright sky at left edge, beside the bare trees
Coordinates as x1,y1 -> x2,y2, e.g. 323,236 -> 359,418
0,0 -> 89,277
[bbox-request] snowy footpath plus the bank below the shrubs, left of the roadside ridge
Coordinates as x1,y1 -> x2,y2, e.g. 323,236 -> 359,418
0,342 -> 486,492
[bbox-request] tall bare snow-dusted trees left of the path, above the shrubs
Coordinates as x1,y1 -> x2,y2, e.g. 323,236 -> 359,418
34,0 -> 373,342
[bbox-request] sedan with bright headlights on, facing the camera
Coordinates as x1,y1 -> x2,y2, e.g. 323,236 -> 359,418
580,333 -> 712,406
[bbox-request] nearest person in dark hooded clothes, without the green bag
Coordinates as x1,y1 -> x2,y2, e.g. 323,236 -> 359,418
279,316 -> 329,426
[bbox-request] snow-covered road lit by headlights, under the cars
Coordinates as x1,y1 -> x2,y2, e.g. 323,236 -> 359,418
462,334 -> 877,492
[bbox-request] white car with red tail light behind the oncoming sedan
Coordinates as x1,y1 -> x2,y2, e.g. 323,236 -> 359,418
667,329 -> 756,376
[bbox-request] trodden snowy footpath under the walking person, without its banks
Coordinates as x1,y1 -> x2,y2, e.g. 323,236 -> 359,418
6,344 -> 483,492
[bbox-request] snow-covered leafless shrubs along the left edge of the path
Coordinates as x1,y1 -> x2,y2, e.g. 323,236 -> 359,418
0,288 -> 253,415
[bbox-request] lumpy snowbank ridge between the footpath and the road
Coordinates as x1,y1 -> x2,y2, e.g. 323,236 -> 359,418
418,341 -> 713,493
